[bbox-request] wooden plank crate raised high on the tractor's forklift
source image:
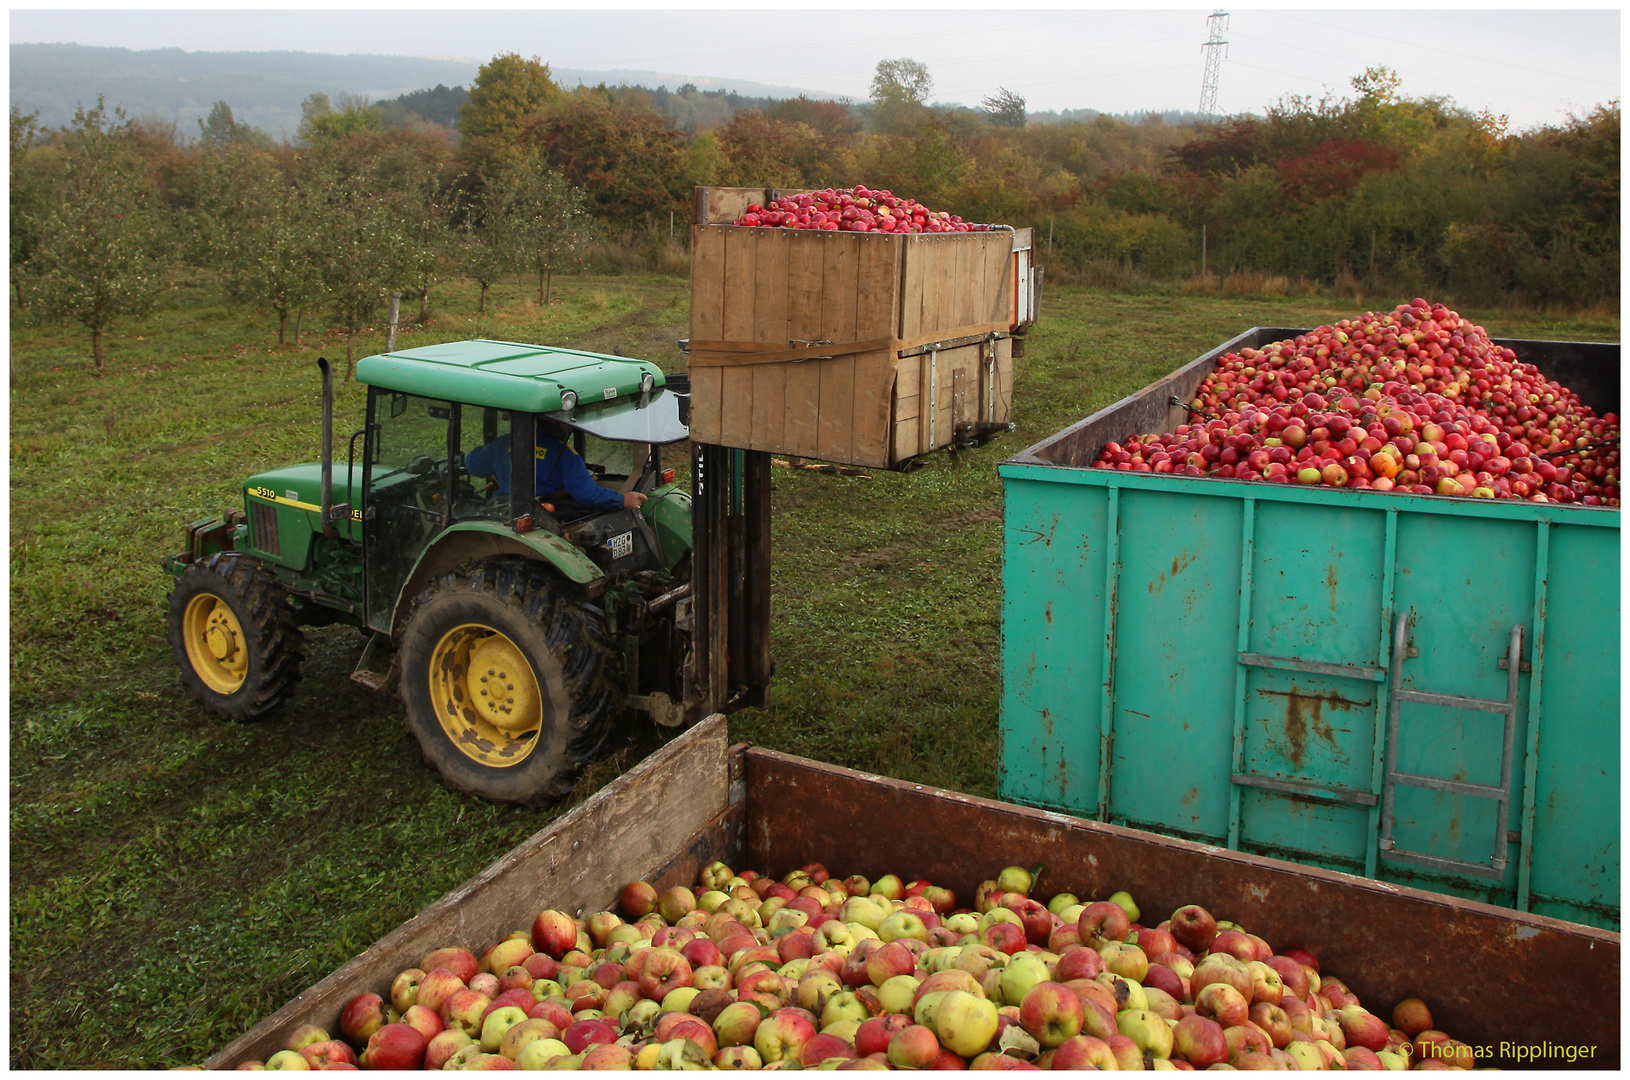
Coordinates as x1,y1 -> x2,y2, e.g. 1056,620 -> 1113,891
689,189 -> 1019,468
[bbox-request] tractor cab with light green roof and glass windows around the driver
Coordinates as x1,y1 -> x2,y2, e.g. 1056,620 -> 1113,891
350,340 -> 691,634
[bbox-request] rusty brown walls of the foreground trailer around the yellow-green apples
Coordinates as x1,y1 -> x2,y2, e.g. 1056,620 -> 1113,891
205,715 -> 1620,1069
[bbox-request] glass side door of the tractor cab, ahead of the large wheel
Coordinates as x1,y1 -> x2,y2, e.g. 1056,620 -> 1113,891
363,391 -> 455,626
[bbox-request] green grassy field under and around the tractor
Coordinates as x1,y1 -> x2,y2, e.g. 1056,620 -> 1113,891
10,268 -> 1619,1069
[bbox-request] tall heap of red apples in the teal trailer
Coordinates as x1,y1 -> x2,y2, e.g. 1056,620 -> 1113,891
1094,298 -> 1619,507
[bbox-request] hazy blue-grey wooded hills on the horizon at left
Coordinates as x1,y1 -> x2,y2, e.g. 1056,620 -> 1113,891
11,44 -> 831,140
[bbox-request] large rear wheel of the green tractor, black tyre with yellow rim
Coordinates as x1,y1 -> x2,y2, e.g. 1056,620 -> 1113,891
398,559 -> 618,806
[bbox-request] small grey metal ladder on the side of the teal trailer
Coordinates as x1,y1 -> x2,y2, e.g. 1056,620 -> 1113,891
1381,611 -> 1524,881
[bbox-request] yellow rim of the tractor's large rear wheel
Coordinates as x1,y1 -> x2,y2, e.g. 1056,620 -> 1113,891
430,624 -> 543,769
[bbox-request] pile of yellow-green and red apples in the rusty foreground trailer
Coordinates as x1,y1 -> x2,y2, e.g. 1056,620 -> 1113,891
226,862 -> 1472,1069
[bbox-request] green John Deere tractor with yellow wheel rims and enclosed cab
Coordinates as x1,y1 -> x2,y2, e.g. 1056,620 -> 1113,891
163,340 -> 713,805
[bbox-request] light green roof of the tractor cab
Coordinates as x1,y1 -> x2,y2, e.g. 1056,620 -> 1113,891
357,339 -> 667,412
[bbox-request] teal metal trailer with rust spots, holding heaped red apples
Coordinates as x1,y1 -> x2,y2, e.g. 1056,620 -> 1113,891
998,327 -> 1620,929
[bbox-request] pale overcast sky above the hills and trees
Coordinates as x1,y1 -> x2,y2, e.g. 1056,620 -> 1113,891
11,3 -> 1620,129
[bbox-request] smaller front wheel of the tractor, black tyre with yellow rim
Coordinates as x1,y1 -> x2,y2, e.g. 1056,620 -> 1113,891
170,552 -> 303,720
